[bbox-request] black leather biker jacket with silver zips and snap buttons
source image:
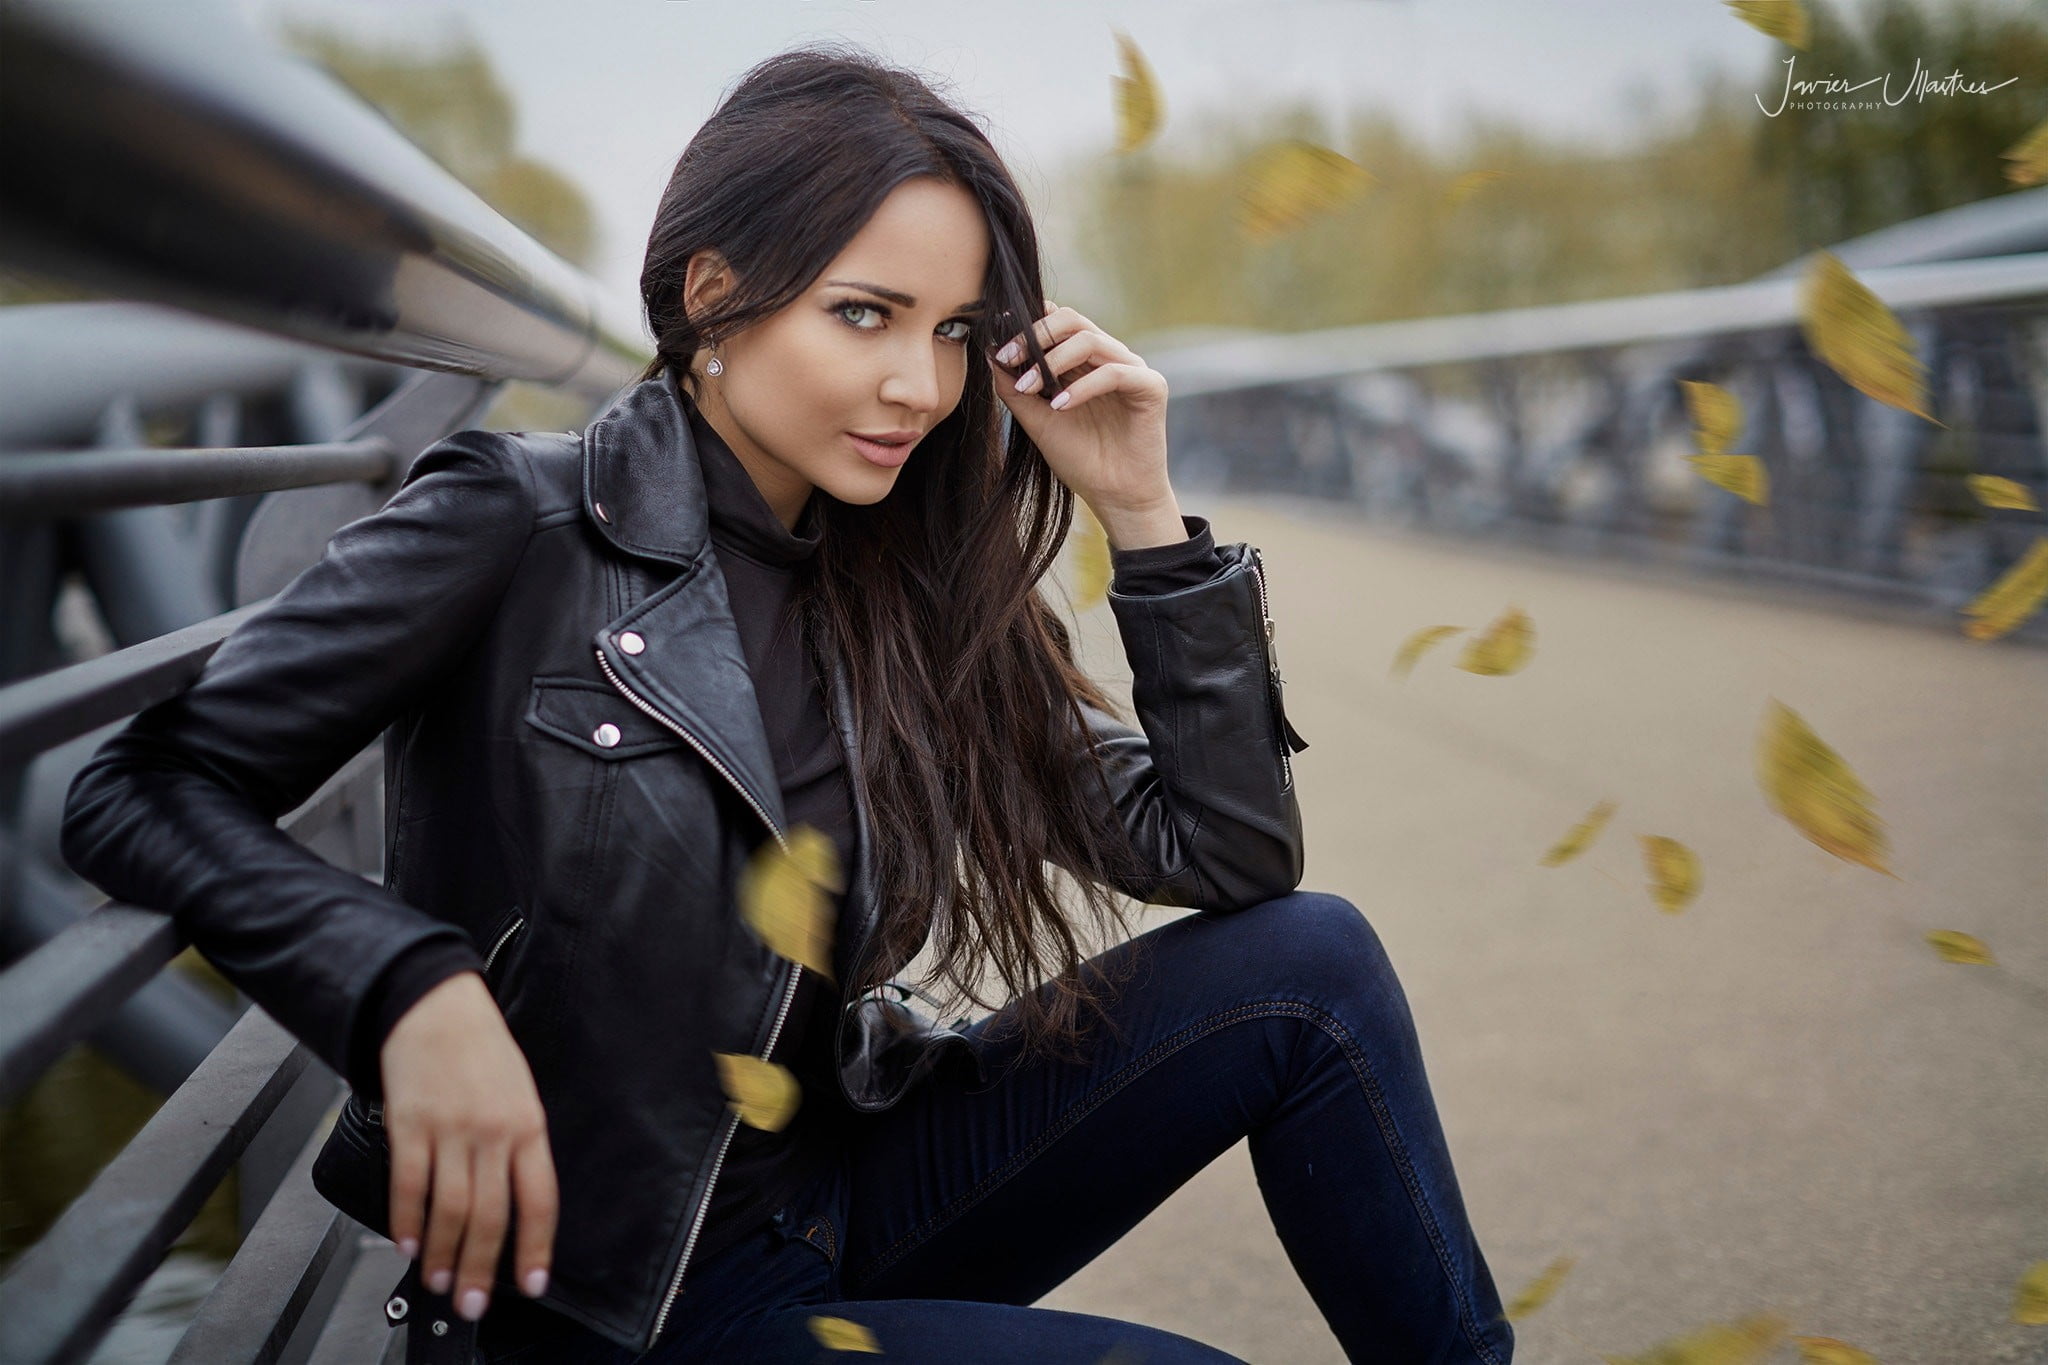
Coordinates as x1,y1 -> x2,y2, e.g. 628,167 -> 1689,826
61,375 -> 1303,1351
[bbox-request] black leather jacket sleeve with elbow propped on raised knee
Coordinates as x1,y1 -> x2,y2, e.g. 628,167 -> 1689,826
1077,524 -> 1307,911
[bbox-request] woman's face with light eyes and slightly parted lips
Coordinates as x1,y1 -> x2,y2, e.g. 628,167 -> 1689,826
684,176 -> 989,528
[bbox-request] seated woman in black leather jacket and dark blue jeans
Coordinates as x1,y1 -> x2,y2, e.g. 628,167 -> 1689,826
63,49 -> 1511,1365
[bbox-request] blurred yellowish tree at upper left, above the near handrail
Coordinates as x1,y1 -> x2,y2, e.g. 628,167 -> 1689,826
283,20 -> 596,268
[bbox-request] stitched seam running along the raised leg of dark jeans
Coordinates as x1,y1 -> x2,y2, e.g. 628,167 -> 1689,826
846,1001 -> 1503,1365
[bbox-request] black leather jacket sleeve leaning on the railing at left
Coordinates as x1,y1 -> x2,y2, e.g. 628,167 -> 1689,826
59,432 -> 535,1095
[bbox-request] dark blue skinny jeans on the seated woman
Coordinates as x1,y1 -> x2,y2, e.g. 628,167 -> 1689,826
483,892 -> 1513,1365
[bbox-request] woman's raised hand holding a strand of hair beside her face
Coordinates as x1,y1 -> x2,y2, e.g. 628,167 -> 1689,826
987,299 -> 1171,514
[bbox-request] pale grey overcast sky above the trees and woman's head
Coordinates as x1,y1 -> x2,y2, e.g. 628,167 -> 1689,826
238,0 -> 1925,321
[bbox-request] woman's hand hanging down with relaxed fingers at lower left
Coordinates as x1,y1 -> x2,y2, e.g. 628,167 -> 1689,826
379,972 -> 557,1322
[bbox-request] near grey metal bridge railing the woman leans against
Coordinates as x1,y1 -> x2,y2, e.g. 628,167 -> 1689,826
0,0 -> 645,1365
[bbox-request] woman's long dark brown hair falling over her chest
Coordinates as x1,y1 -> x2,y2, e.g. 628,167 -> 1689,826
641,45 -> 1163,1056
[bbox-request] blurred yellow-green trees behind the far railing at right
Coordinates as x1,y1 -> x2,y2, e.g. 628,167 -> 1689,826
1075,0 -> 2048,336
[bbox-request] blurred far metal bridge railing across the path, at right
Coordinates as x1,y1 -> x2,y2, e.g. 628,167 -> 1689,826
1147,188 -> 2048,643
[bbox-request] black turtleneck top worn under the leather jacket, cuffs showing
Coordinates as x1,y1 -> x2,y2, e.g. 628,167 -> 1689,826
348,397 -> 1223,1267
